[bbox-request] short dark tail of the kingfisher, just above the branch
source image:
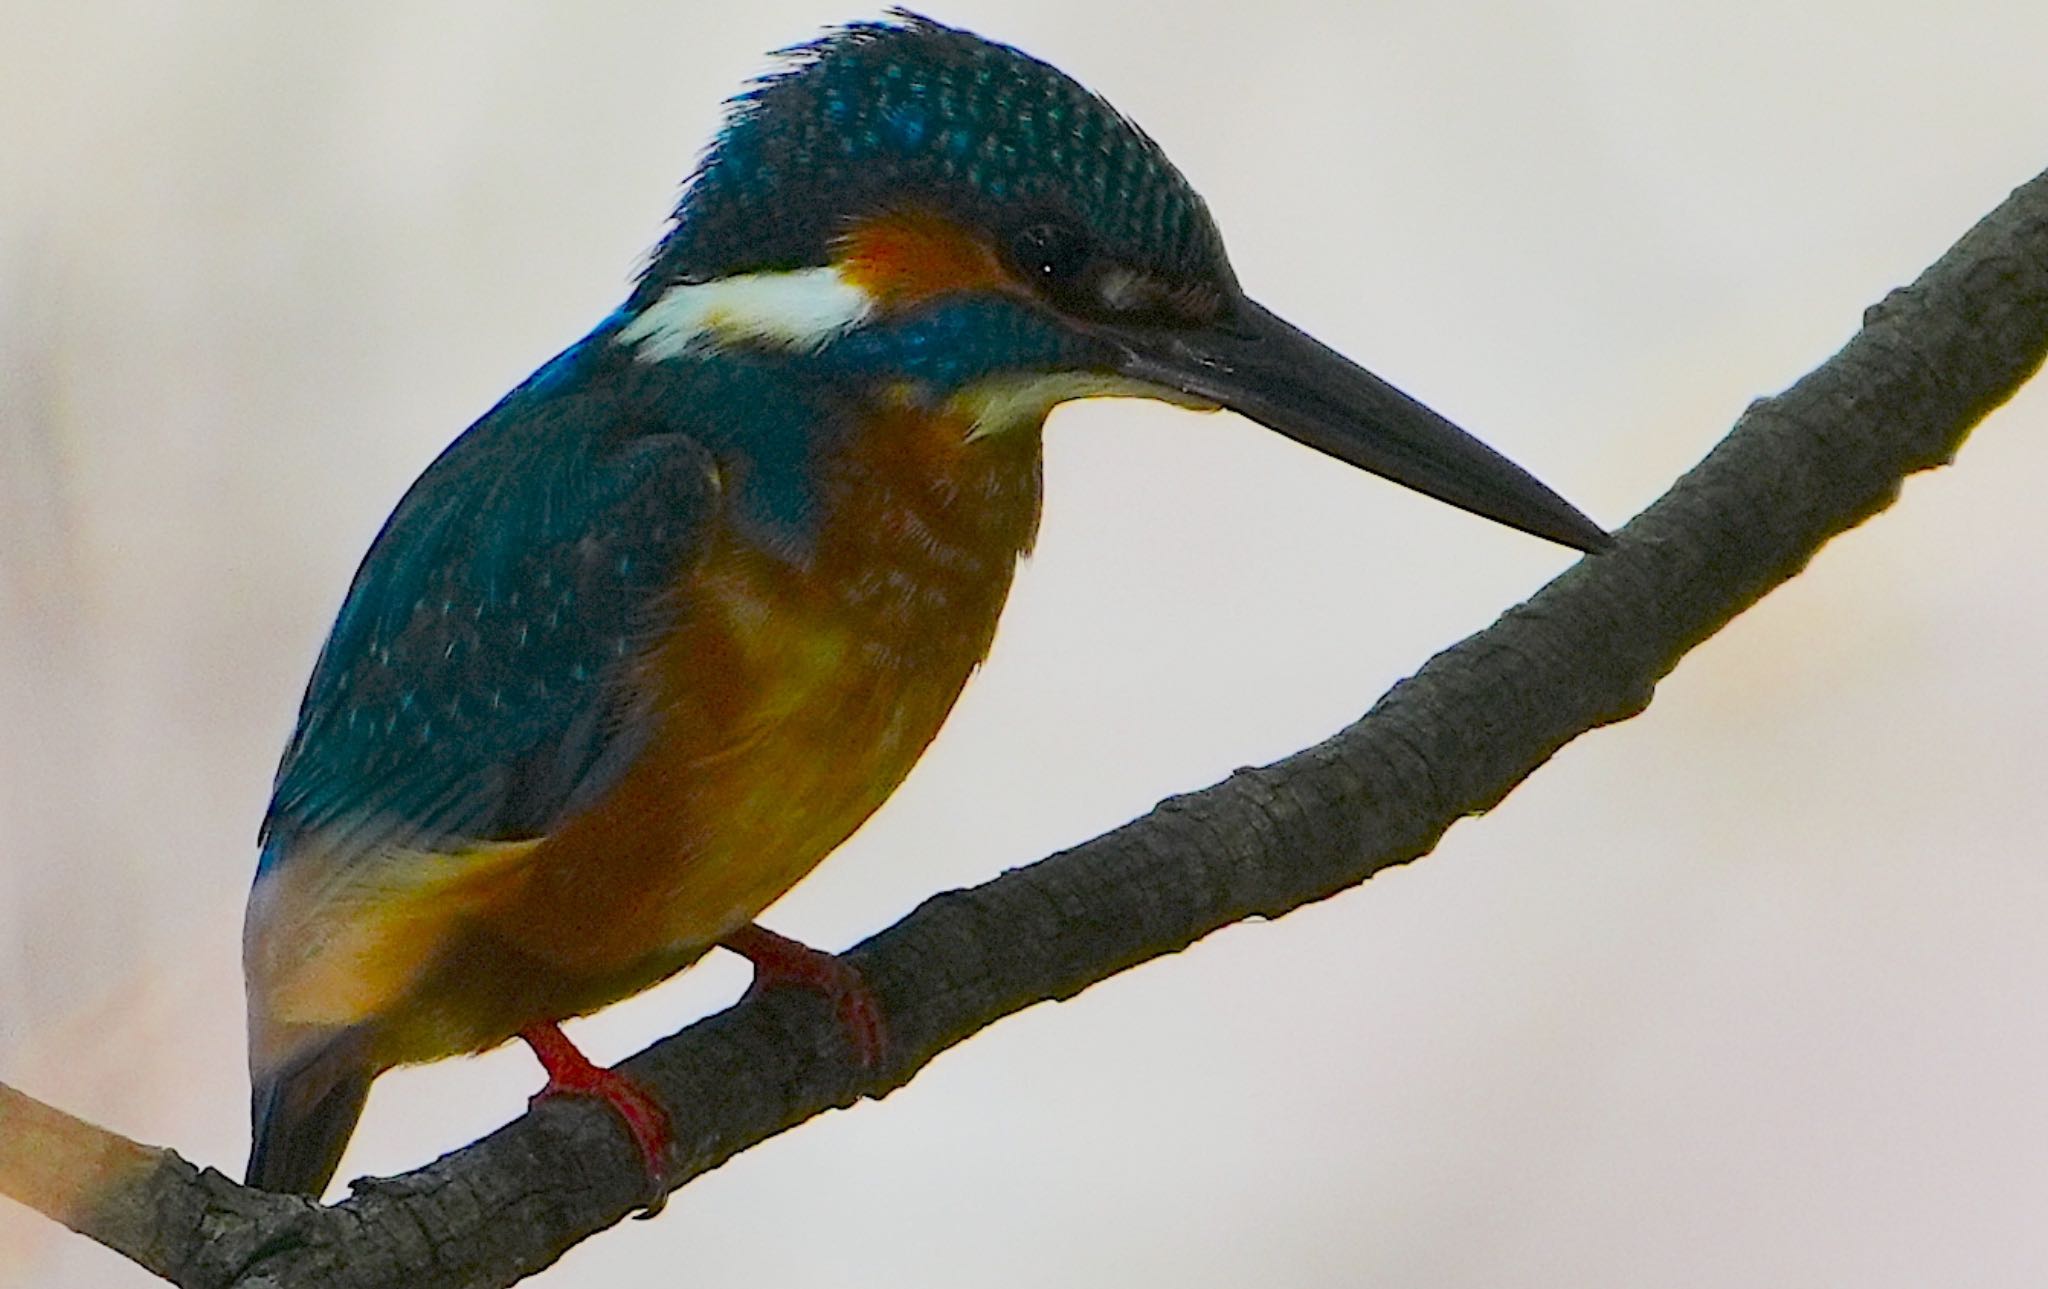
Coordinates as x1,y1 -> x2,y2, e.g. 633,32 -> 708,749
244,1033 -> 377,1199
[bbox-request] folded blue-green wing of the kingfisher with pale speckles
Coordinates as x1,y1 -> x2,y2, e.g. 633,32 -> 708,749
264,338 -> 717,869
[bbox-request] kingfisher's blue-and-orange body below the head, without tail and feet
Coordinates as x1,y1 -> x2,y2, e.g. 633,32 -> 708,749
250,329 -> 1038,1064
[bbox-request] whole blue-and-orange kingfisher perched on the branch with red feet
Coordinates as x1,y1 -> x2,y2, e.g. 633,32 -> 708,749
244,10 -> 1608,1201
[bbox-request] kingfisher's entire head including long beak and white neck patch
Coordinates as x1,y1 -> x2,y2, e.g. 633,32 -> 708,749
618,12 -> 1608,549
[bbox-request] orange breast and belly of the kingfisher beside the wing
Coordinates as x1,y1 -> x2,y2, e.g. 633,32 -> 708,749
492,397 -> 1038,979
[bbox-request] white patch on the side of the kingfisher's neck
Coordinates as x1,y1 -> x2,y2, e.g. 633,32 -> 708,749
618,264 -> 874,363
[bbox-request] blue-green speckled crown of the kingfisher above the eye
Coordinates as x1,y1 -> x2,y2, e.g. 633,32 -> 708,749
637,14 -> 1229,299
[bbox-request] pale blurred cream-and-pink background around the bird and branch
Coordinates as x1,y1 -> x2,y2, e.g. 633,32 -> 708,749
0,0 -> 2048,1289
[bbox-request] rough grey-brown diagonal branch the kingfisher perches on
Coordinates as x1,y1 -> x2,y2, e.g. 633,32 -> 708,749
12,165 -> 2048,1289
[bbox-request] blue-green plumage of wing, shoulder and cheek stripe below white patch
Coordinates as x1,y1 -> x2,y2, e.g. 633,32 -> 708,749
266,284 -> 1087,857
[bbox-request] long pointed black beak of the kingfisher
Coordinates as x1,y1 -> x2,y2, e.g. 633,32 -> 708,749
1106,299 -> 1612,551
